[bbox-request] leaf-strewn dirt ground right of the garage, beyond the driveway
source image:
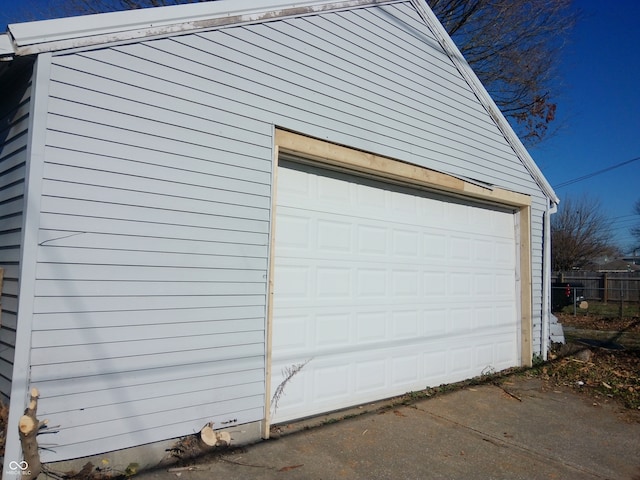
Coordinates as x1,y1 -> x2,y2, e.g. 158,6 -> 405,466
531,314 -> 640,416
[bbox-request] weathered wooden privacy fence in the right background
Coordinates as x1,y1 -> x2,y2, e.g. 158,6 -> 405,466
551,271 -> 640,303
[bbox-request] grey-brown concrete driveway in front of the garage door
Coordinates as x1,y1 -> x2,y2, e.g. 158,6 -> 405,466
136,377 -> 640,480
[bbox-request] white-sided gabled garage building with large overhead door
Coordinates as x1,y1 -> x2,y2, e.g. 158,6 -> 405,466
0,0 -> 558,472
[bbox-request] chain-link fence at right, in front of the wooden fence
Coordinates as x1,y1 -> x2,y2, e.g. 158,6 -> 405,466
551,272 -> 640,318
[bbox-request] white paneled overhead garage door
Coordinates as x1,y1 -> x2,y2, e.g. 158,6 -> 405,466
271,162 -> 520,422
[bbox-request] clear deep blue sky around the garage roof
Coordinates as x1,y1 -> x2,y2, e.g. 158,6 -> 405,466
0,0 -> 640,252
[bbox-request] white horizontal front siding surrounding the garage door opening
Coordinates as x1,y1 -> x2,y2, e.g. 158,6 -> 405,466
31,3 -> 544,461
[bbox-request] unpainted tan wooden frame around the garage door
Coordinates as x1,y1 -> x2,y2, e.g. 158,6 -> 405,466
262,128 -> 533,438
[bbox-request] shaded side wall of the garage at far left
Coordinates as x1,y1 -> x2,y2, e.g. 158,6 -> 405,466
0,63 -> 31,403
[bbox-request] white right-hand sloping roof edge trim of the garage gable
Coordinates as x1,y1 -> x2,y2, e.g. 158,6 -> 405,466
411,0 -> 560,204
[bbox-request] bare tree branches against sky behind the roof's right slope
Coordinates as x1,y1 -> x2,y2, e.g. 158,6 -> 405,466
427,0 -> 577,144
